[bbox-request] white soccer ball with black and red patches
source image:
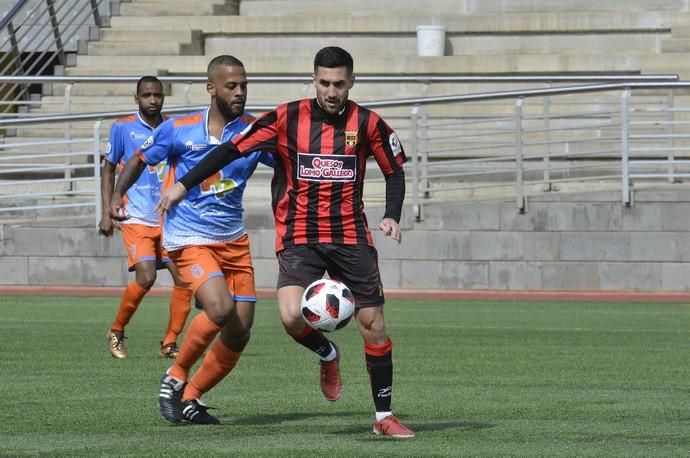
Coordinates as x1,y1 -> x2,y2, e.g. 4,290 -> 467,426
300,278 -> 355,332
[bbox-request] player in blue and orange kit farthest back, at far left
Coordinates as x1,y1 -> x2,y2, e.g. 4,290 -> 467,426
98,76 -> 192,359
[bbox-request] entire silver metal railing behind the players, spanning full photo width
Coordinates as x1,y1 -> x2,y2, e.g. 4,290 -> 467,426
0,82 -> 690,225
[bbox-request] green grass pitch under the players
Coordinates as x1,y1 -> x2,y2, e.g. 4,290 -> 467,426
0,296 -> 690,458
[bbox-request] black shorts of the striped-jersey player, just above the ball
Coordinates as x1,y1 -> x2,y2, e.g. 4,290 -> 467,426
278,243 -> 385,308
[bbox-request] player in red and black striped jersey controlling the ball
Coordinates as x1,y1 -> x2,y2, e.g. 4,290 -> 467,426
158,47 -> 414,438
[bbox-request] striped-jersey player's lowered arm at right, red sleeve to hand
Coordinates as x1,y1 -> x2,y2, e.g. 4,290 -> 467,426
369,118 -> 407,243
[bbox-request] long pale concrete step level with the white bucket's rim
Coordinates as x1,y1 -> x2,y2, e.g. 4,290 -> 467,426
111,11 -> 676,35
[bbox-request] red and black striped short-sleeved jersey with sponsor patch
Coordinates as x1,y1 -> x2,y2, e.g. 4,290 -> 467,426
232,99 -> 407,251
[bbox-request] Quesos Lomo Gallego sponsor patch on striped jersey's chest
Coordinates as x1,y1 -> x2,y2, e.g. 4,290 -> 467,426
297,153 -> 357,182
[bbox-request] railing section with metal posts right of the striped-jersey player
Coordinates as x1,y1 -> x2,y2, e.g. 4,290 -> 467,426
408,82 -> 690,219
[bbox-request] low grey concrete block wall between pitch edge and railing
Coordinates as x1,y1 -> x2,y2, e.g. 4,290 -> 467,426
0,185 -> 690,291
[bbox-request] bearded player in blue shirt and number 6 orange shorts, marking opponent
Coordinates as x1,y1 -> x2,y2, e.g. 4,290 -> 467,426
110,56 -> 273,424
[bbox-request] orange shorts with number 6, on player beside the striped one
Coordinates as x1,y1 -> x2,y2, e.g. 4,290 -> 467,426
170,234 -> 256,302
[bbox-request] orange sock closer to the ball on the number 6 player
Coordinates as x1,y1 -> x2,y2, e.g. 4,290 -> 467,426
182,339 -> 242,400
